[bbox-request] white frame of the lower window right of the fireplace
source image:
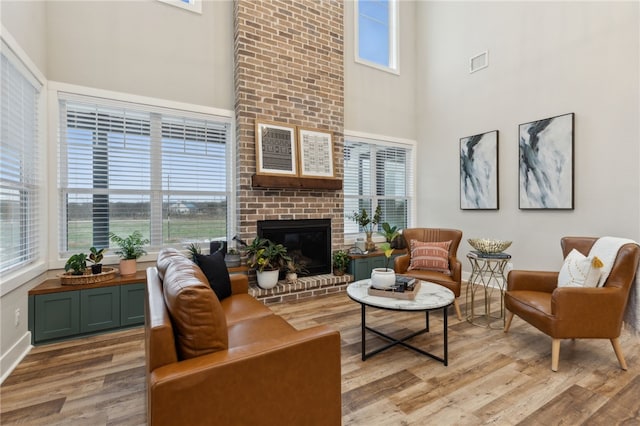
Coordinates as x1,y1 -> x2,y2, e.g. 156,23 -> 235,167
343,130 -> 417,244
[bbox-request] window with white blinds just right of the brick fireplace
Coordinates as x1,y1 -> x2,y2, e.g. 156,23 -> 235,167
343,137 -> 413,234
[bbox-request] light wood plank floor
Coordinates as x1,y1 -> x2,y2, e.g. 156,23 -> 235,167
0,282 -> 640,426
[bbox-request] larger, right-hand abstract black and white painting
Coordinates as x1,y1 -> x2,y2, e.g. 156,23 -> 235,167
518,113 -> 574,210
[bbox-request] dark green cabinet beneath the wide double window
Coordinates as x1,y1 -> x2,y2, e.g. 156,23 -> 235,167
29,283 -> 146,344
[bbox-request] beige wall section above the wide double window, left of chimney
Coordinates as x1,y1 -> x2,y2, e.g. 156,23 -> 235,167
47,0 -> 234,110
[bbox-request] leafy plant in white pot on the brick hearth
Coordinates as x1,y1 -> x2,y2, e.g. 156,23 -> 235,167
247,237 -> 291,289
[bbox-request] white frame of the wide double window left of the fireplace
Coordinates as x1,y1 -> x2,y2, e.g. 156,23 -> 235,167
48,81 -> 237,267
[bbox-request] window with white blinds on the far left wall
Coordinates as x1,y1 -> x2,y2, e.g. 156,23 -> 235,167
0,42 -> 43,273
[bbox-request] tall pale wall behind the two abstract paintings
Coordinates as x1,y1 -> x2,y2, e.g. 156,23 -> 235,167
416,2 -> 640,270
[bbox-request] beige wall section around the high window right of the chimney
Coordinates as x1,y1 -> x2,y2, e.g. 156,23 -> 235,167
344,1 -> 417,140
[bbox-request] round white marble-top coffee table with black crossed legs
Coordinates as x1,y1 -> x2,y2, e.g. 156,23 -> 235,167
347,279 -> 455,365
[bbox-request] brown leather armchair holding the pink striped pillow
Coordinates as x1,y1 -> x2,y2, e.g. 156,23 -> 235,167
394,228 -> 462,321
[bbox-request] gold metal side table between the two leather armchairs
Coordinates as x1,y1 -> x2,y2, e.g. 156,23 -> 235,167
465,251 -> 511,328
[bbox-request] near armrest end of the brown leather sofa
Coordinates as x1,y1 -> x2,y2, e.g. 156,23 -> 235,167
148,326 -> 341,425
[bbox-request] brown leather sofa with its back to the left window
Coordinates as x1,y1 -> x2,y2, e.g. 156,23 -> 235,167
145,249 -> 341,426
